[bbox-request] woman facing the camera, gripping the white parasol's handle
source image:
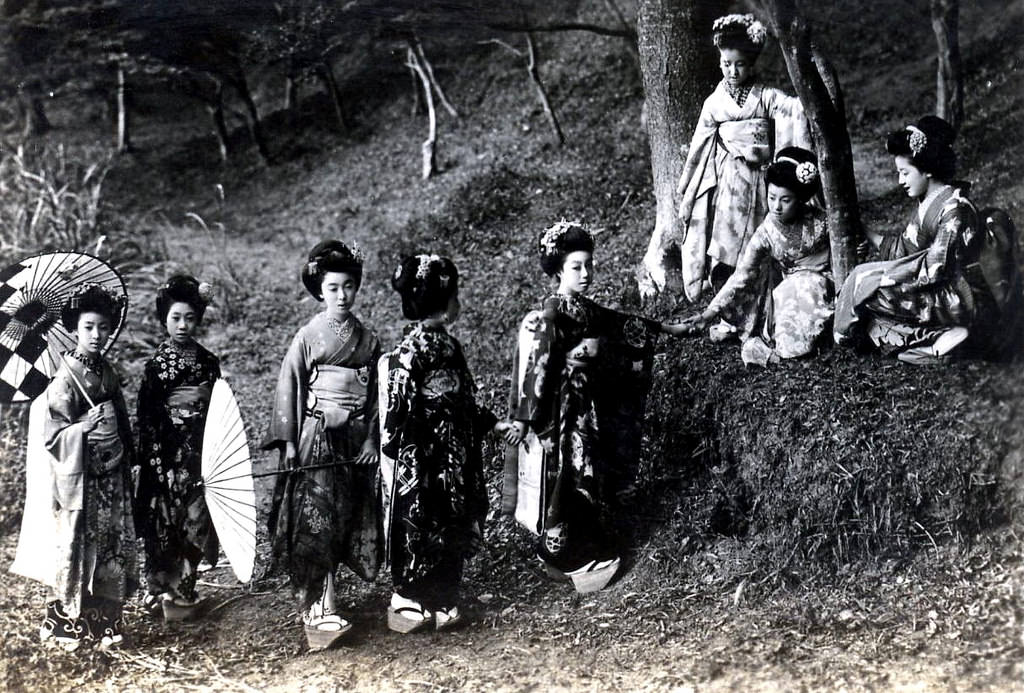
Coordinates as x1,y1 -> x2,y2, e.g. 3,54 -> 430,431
264,241 -> 383,650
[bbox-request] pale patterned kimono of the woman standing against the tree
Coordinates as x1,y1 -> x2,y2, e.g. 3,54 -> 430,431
648,80 -> 813,301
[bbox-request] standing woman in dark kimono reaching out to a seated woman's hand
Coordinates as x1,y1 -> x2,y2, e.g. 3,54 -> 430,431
503,221 -> 684,592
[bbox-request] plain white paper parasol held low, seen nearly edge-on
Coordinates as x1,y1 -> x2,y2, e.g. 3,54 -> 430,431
202,379 -> 256,582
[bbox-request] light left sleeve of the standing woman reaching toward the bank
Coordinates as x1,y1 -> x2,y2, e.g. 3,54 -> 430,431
512,310 -> 558,424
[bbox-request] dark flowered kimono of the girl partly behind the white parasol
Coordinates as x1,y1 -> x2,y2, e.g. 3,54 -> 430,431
135,341 -> 220,599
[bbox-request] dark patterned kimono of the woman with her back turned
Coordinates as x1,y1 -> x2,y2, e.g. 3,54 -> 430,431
379,324 -> 497,608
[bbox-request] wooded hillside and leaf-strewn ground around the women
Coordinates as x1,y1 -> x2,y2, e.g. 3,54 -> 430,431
0,0 -> 1024,691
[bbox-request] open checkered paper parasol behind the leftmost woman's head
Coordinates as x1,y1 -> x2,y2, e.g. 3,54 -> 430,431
0,253 -> 128,403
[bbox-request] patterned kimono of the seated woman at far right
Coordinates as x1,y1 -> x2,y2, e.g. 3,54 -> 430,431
835,186 -> 992,360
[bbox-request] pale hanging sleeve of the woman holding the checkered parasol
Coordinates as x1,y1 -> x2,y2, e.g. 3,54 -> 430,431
43,369 -> 87,510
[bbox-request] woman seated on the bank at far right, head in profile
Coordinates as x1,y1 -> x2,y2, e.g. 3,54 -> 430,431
835,116 -> 995,363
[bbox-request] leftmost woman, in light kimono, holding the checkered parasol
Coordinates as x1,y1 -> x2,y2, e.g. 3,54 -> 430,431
27,285 -> 138,650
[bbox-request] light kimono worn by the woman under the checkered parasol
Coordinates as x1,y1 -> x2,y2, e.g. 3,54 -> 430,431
18,353 -> 137,626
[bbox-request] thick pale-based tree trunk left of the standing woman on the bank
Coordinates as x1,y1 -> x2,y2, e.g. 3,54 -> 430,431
637,0 -> 726,297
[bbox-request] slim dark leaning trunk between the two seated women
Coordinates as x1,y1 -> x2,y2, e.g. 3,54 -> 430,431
764,0 -> 863,287
